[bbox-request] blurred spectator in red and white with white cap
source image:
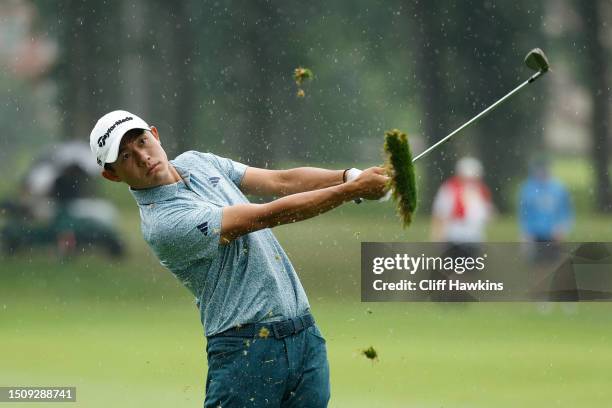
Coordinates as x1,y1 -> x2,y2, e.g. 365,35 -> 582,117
431,157 -> 494,244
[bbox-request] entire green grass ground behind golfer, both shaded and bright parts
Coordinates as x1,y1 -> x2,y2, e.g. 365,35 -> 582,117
0,155 -> 612,408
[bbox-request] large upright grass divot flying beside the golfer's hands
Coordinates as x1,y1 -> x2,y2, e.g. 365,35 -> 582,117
384,129 -> 417,228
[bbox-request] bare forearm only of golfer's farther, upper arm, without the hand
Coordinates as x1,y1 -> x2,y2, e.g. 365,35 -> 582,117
282,167 -> 344,195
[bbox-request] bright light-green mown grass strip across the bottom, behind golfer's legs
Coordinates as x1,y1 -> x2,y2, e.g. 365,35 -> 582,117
0,299 -> 612,407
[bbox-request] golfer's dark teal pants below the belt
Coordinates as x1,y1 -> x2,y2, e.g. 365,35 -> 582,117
204,324 -> 330,408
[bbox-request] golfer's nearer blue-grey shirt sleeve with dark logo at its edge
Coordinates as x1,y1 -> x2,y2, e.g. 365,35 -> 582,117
151,201 -> 223,269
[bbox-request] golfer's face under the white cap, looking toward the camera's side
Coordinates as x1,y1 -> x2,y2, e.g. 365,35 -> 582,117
102,127 -> 172,189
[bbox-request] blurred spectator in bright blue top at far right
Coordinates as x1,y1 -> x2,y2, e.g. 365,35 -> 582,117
519,157 -> 574,262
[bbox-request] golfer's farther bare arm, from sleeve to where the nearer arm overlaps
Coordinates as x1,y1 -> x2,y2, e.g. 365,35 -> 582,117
240,167 -> 344,196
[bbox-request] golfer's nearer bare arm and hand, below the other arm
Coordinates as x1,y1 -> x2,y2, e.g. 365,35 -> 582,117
221,167 -> 389,244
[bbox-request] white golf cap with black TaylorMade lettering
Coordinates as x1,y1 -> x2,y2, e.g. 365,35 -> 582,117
89,110 -> 149,166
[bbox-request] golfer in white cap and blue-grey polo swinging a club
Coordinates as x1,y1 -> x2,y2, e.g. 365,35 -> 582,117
90,111 -> 388,408
